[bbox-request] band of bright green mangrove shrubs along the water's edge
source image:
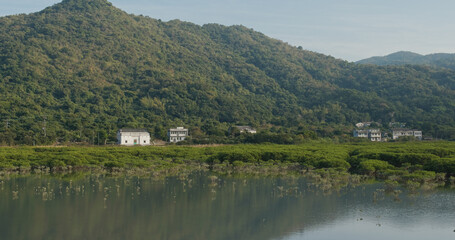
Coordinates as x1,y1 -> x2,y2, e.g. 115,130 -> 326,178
0,142 -> 455,188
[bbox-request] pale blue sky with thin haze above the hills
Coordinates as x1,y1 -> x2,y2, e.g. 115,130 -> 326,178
0,0 -> 455,61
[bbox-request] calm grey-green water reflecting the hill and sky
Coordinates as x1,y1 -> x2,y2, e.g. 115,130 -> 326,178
0,174 -> 455,240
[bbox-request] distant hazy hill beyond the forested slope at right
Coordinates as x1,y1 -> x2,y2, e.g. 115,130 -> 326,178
357,52 -> 455,70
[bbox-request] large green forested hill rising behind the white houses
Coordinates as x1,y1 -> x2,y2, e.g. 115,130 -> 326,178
0,0 -> 455,144
